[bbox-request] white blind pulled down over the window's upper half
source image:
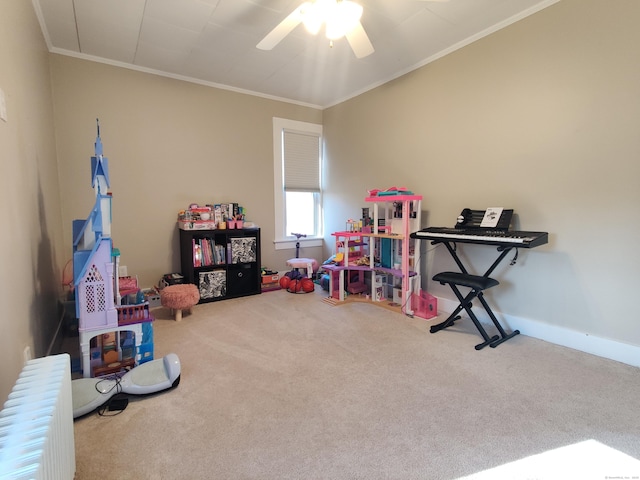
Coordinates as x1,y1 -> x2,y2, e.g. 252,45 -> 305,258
283,130 -> 320,192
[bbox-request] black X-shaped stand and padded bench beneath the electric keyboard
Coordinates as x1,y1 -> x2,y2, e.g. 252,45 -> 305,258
430,240 -> 520,350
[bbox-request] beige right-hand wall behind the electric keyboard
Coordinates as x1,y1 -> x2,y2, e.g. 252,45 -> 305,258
324,0 -> 640,352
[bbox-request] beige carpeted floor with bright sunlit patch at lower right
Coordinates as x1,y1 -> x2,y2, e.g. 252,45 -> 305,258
75,291 -> 640,480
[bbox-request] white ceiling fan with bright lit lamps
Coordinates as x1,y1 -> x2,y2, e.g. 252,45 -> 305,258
256,0 -> 449,58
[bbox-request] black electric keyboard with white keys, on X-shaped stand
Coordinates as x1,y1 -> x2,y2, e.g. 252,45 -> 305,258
410,227 -> 549,248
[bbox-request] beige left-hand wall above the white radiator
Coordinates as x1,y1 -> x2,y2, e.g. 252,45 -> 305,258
0,0 -> 64,405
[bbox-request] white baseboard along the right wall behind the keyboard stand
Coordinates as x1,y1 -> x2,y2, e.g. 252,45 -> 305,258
431,297 -> 640,367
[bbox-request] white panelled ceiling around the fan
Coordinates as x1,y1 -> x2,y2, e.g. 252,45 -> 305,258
33,0 -> 559,108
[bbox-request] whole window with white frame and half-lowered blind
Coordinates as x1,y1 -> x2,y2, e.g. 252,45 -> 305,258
273,118 -> 322,249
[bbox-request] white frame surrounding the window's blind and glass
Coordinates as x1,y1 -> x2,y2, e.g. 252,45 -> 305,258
273,117 -> 324,250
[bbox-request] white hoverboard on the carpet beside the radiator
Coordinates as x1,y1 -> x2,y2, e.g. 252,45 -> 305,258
71,353 -> 180,418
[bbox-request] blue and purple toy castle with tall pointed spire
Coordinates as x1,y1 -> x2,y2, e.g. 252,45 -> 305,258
73,123 -> 153,377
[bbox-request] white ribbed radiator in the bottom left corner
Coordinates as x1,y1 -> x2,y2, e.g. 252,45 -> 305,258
0,353 -> 76,480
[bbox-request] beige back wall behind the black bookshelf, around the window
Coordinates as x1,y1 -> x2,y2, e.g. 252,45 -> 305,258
51,55 -> 322,286
